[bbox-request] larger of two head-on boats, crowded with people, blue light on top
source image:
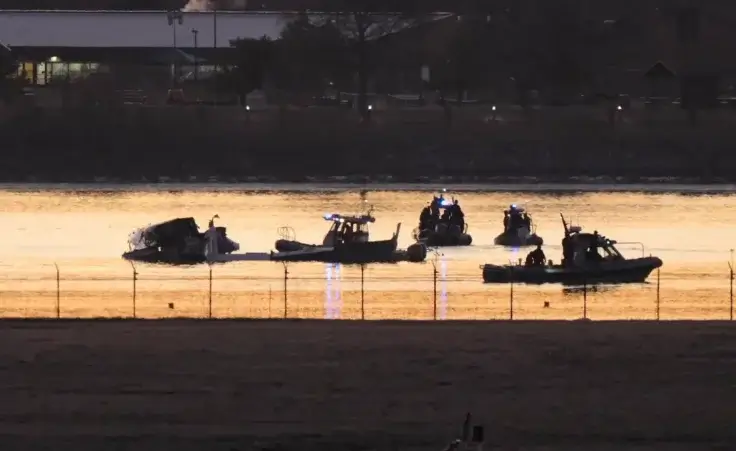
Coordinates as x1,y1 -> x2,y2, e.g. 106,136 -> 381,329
413,190 -> 473,247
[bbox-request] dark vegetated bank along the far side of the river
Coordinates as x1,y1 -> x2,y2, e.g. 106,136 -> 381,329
0,106 -> 736,183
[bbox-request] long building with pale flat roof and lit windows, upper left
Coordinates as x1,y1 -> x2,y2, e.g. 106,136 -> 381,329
0,10 -> 294,85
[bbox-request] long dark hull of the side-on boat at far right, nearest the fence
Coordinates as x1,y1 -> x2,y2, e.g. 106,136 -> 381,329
483,257 -> 662,285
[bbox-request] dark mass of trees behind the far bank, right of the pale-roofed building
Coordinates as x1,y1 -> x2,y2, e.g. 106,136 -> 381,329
221,1 -> 613,114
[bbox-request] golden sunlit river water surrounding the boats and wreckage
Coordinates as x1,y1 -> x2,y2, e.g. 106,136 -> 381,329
0,185 -> 736,319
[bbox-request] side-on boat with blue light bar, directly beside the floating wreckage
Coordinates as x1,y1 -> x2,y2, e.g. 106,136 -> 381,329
271,208 -> 427,264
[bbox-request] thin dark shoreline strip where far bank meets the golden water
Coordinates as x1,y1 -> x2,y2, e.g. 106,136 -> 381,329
0,176 -> 736,194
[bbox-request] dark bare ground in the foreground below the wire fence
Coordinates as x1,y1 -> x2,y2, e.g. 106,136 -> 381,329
0,320 -> 736,451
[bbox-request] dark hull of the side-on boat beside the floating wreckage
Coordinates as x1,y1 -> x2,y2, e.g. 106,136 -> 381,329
271,240 -> 427,264
